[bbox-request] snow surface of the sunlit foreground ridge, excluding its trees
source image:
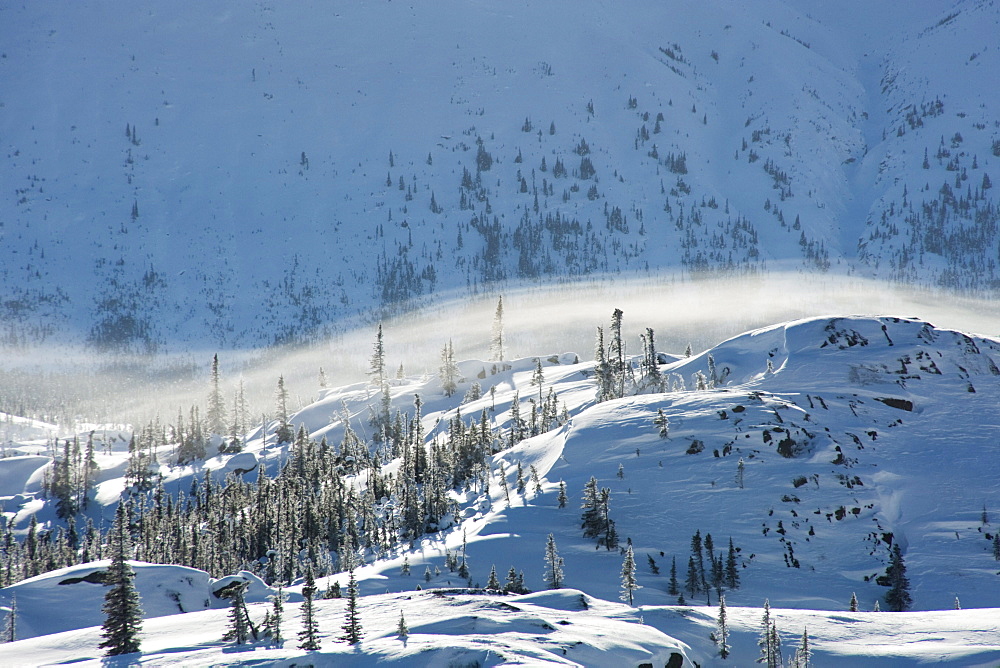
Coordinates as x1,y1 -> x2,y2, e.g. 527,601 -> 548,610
0,317 -> 1000,665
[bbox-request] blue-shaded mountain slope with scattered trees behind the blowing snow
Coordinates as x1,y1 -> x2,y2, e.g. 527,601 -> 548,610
0,0 -> 1000,350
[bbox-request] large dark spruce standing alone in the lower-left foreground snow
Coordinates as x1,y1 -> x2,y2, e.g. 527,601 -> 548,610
99,502 -> 142,656
